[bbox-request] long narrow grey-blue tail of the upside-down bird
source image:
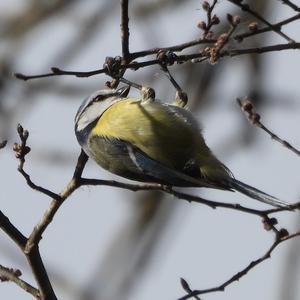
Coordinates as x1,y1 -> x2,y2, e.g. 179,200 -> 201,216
228,178 -> 289,208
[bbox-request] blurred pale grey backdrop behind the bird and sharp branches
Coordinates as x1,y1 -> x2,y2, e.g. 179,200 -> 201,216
0,0 -> 300,300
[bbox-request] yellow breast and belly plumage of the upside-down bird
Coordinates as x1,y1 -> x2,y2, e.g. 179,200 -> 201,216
92,99 -> 198,169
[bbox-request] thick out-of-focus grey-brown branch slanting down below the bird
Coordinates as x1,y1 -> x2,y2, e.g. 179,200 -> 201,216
77,191 -> 178,300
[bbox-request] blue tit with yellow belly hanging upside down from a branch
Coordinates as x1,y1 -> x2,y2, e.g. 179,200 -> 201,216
75,87 -> 287,207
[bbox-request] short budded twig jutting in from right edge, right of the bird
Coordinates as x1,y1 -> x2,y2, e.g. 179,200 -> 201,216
237,98 -> 300,156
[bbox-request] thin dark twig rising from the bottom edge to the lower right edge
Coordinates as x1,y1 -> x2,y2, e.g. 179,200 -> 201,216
178,231 -> 300,300
